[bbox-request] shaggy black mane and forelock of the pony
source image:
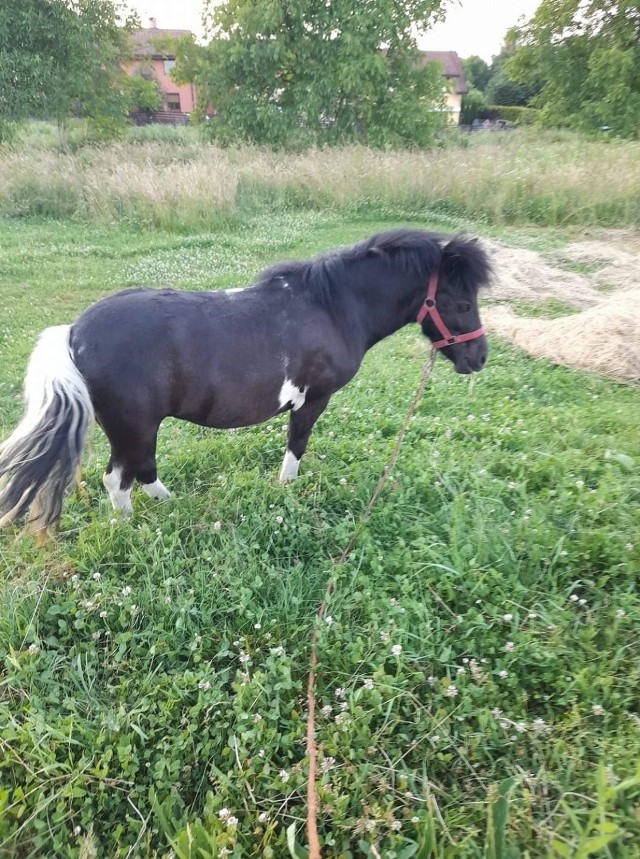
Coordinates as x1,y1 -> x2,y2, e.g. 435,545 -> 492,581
258,229 -> 491,304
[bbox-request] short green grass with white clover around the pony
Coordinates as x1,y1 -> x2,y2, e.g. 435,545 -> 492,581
0,214 -> 640,859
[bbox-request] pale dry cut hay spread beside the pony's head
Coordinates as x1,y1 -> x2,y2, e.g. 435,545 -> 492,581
482,235 -> 640,384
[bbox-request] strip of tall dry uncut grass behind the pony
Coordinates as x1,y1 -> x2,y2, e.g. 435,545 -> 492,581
0,130 -> 640,229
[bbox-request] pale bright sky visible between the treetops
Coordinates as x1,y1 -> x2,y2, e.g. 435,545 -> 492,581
129,0 -> 540,62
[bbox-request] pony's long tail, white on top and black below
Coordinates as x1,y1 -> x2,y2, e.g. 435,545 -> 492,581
0,325 -> 94,536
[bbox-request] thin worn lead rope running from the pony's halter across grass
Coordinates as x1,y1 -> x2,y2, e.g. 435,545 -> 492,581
307,349 -> 438,859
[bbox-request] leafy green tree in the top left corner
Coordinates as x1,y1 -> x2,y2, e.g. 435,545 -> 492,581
0,0 -> 136,138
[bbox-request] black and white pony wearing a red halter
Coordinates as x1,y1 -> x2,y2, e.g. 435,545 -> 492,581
0,230 -> 490,534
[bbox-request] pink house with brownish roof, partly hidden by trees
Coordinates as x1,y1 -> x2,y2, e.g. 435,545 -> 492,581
125,18 -> 196,117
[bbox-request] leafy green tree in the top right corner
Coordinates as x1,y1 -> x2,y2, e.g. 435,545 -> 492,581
505,0 -> 640,137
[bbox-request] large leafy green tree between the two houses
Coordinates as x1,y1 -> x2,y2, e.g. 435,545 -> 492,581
178,0 -> 447,146
